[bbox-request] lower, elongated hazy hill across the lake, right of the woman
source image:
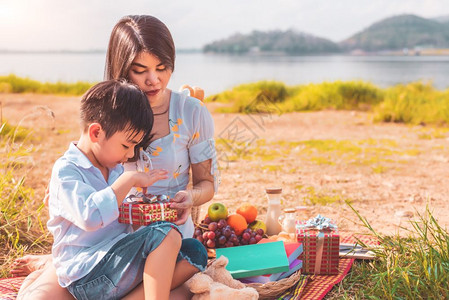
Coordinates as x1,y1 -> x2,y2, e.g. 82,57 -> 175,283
203,30 -> 340,55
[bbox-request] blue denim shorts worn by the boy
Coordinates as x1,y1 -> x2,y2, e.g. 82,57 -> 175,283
67,222 -> 207,300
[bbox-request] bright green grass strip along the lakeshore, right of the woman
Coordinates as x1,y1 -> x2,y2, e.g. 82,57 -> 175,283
206,81 -> 449,125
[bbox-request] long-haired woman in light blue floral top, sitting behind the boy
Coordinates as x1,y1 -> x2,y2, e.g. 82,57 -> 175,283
15,16 -> 218,299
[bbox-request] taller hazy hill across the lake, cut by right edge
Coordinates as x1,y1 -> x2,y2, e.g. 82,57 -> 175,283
340,15 -> 449,52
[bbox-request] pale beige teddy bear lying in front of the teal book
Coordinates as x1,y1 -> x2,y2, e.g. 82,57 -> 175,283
186,256 -> 259,300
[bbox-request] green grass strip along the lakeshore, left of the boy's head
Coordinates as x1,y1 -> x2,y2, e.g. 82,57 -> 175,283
0,74 -> 94,96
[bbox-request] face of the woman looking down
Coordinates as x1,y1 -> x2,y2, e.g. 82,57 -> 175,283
128,52 -> 172,107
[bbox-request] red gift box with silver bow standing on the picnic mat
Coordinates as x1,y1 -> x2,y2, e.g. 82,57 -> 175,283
296,215 -> 340,275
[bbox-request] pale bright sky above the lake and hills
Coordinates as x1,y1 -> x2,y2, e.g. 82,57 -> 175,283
0,0 -> 449,50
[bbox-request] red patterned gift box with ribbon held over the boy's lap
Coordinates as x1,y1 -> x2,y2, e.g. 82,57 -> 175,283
118,195 -> 178,225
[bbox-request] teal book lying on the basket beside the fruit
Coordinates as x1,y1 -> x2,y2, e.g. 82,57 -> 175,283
216,241 -> 289,278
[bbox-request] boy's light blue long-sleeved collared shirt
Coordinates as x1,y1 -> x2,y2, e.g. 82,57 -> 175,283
47,143 -> 132,287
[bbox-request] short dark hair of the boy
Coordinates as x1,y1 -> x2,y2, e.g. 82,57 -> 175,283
80,80 -> 153,158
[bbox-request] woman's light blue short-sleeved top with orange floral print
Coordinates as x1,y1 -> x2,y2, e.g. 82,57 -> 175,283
125,91 -> 219,237
